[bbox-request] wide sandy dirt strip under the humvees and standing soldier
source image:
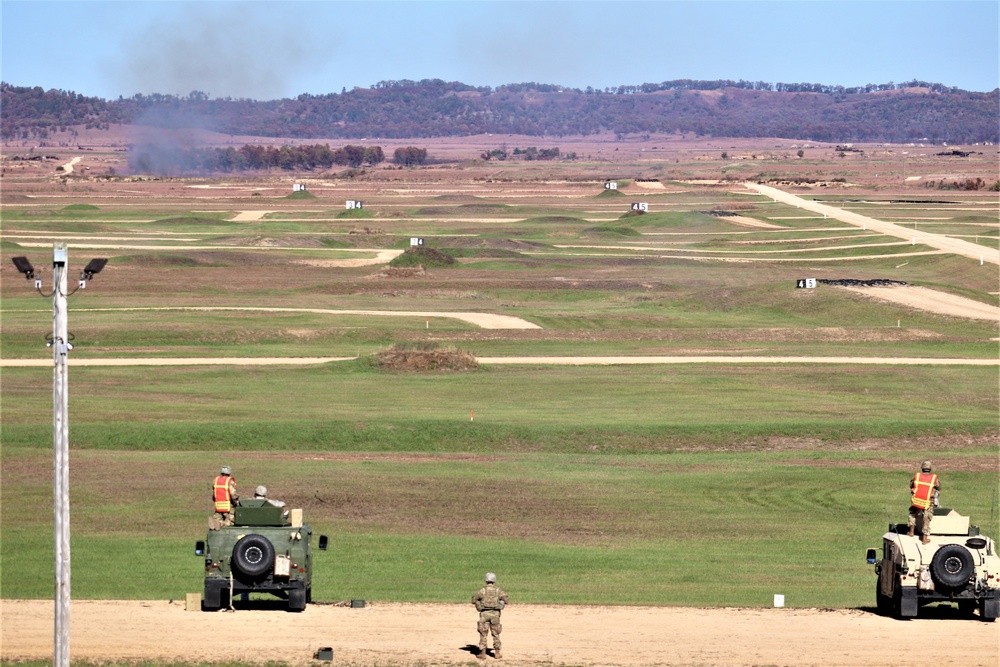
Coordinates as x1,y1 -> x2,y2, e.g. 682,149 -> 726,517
0,600 -> 1000,667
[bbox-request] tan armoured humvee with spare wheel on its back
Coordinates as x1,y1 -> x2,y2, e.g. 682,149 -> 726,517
866,507 -> 1000,621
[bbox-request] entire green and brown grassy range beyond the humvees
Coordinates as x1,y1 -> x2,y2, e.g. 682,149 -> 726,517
0,172 -> 1000,620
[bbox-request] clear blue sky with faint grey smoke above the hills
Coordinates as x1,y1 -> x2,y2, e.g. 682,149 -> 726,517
0,0 -> 1000,100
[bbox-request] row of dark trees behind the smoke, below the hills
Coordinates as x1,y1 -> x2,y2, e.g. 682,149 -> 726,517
129,144 -> 427,175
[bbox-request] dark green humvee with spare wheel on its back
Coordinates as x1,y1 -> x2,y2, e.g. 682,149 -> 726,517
195,499 -> 327,611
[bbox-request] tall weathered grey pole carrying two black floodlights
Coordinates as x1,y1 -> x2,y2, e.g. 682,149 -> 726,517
52,243 -> 70,667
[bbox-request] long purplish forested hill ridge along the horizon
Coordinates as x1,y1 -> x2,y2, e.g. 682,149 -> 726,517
0,79 -> 1000,144
